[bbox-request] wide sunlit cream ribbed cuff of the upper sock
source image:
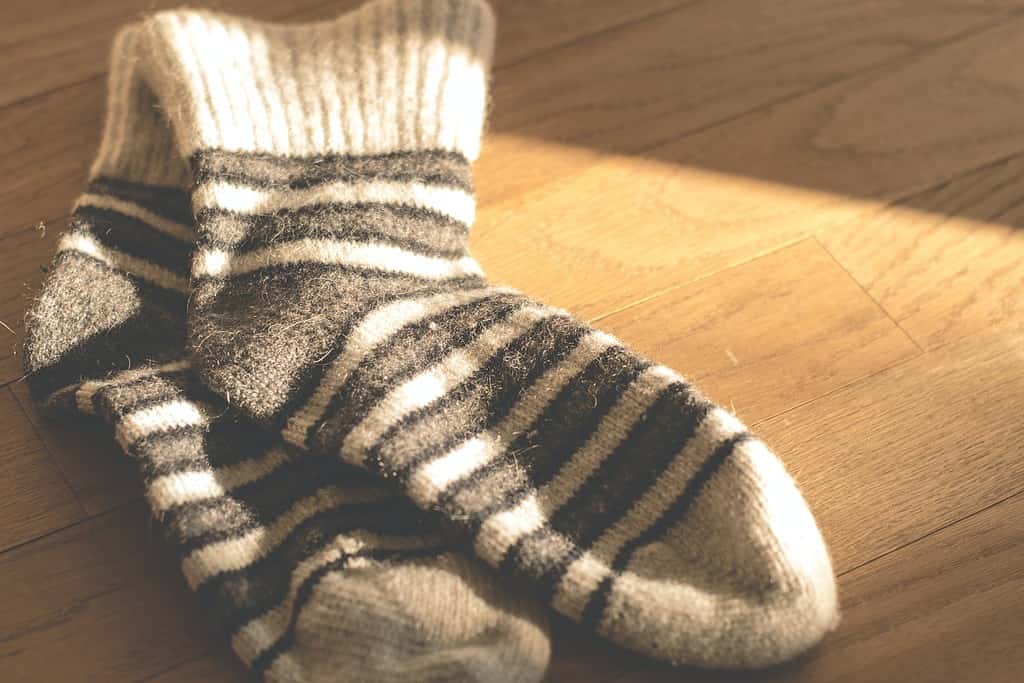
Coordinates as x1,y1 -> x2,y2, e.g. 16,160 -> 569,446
146,0 -> 495,160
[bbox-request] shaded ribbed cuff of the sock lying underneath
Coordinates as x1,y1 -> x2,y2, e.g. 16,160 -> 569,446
89,24 -> 188,187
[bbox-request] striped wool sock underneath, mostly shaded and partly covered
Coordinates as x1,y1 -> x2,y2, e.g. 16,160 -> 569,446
19,29 -> 549,682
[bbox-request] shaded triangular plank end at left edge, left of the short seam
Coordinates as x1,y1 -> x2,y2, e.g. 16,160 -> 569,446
0,388 -> 84,551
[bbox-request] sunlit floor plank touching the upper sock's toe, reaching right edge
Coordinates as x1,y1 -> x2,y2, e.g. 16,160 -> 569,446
755,327 -> 1024,571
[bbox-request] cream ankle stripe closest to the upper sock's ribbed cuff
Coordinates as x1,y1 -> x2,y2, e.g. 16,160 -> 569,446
193,180 -> 476,225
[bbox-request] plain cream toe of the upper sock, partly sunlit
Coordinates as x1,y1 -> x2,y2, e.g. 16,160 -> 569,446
598,430 -> 839,669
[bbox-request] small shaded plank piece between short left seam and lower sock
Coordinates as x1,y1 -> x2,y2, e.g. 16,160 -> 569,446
9,382 -> 142,516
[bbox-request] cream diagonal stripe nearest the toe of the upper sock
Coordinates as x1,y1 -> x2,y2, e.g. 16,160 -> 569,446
552,408 -> 745,618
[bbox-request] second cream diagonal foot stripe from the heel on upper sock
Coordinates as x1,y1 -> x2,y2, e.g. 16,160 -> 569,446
340,305 -> 565,473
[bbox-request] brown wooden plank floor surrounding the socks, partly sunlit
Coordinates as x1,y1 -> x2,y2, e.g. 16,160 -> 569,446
0,0 -> 1024,683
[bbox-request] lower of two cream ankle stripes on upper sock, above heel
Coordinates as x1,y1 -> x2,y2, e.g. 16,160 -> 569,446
193,239 -> 483,280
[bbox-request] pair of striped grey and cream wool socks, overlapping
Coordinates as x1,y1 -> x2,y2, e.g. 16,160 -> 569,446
27,0 -> 837,680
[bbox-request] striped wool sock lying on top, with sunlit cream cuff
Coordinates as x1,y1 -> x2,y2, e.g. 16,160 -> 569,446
138,0 -> 837,668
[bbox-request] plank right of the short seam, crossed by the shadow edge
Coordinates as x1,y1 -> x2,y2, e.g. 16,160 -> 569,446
820,151 -> 1024,347
